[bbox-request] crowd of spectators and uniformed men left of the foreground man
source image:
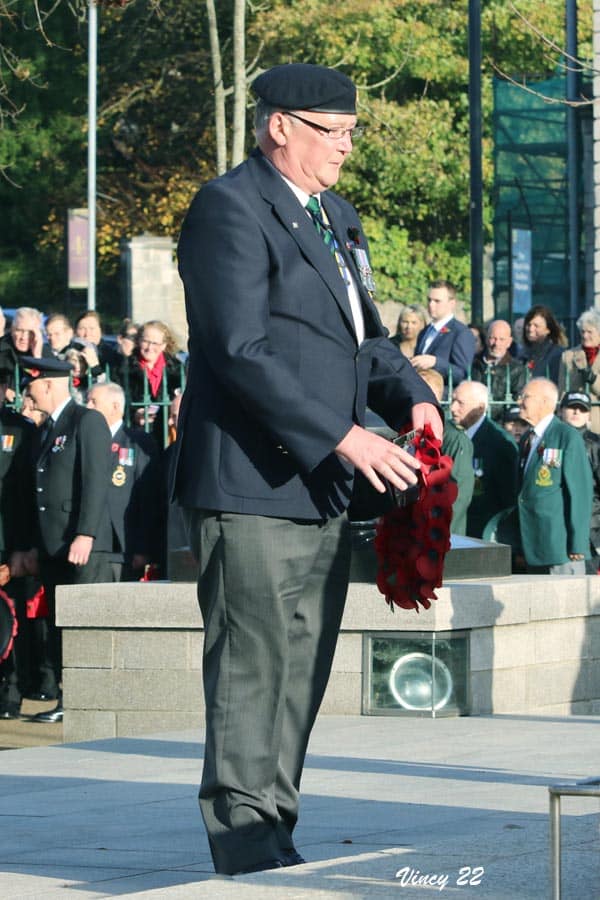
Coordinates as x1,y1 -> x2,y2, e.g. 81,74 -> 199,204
0,307 -> 185,722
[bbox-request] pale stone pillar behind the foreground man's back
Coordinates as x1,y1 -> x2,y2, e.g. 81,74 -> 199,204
122,234 -> 187,350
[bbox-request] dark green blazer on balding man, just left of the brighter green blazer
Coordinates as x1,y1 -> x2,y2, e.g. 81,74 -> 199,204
467,419 -> 519,538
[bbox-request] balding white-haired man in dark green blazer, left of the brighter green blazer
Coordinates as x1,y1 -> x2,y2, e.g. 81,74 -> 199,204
450,381 -> 518,538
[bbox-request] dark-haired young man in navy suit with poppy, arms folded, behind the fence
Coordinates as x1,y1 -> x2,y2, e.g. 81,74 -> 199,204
411,279 -> 475,387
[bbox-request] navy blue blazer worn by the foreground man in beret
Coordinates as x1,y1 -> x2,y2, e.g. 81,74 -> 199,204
171,150 -> 435,519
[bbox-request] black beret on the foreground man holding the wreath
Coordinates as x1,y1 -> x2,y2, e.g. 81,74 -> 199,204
252,63 -> 356,115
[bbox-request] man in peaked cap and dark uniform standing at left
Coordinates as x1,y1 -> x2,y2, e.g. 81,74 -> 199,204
15,357 -> 112,722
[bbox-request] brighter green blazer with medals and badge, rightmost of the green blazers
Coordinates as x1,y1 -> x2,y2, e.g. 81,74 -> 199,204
517,417 -> 593,566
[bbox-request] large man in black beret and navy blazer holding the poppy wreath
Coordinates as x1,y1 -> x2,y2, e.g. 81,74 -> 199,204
173,64 -> 442,874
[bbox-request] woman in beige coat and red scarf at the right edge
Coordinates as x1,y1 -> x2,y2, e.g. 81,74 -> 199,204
558,307 -> 600,434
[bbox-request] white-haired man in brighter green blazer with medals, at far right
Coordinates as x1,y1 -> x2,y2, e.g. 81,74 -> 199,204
517,378 -> 593,575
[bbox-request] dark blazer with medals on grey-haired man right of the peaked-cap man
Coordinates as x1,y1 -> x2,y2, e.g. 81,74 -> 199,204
108,425 -> 161,562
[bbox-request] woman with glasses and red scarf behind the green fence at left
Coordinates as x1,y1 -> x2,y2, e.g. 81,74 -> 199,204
119,319 -> 181,446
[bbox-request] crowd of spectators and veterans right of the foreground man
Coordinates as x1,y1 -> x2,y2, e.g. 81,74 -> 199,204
392,290 -> 600,573
